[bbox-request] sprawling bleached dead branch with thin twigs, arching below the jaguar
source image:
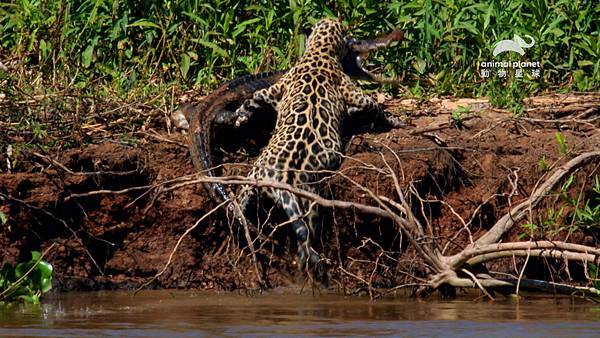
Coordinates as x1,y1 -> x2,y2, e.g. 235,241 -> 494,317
58,142 -> 600,299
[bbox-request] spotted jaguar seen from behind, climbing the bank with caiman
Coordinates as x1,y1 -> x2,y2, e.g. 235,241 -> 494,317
236,19 -> 399,272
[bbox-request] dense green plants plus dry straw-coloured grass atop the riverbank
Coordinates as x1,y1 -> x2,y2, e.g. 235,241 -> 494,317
0,0 -> 600,146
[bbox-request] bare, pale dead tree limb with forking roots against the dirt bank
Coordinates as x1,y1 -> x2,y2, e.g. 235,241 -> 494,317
136,149 -> 600,299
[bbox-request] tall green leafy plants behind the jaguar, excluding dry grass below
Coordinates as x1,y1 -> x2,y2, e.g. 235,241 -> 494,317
0,0 -> 600,94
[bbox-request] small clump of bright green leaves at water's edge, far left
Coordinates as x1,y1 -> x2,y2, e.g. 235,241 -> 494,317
0,251 -> 52,304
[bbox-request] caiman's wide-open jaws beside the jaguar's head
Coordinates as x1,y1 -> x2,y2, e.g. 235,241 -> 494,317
342,28 -> 404,83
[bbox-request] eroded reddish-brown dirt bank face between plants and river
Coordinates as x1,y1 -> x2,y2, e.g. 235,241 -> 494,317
0,93 -> 600,290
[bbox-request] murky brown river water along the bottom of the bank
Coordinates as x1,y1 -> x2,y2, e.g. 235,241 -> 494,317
0,291 -> 600,338
